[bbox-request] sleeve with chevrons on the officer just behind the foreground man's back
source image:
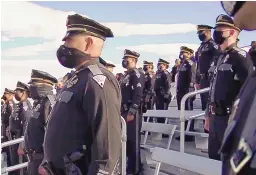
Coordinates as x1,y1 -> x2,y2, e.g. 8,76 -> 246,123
129,69 -> 145,115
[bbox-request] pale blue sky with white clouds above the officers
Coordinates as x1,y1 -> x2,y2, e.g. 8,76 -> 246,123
1,1 -> 256,92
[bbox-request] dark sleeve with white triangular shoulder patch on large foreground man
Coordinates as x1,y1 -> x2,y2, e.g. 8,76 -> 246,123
83,72 -> 121,175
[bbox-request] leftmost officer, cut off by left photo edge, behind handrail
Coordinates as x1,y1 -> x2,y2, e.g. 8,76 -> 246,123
1,88 -> 15,166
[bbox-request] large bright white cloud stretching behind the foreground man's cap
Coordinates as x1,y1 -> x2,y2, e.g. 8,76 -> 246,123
1,1 -> 196,56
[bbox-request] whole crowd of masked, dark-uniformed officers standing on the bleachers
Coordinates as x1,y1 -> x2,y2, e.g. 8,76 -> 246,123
1,2 -> 256,175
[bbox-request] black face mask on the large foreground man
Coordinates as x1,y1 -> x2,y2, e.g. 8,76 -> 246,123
56,45 -> 89,69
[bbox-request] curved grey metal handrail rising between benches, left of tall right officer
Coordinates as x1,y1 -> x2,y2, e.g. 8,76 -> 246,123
180,87 -> 210,153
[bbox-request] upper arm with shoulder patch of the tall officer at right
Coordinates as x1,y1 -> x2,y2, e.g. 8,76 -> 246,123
236,51 -> 253,84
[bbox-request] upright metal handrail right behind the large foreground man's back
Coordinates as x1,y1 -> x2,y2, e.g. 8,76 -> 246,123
121,117 -> 127,174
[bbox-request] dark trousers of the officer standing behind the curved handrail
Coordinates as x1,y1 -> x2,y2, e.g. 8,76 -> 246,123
176,89 -> 194,131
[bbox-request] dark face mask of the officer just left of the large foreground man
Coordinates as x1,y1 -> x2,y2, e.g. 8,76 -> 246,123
29,85 -> 53,99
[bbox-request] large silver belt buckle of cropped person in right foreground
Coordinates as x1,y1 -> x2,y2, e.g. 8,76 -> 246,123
230,135 -> 256,174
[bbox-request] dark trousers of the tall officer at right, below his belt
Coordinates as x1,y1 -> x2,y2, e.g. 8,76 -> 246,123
208,115 -> 229,160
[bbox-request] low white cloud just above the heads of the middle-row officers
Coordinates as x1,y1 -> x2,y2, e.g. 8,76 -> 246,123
116,43 -> 199,64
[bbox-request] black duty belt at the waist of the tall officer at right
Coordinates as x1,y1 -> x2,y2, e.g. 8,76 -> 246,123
209,102 -> 231,116
